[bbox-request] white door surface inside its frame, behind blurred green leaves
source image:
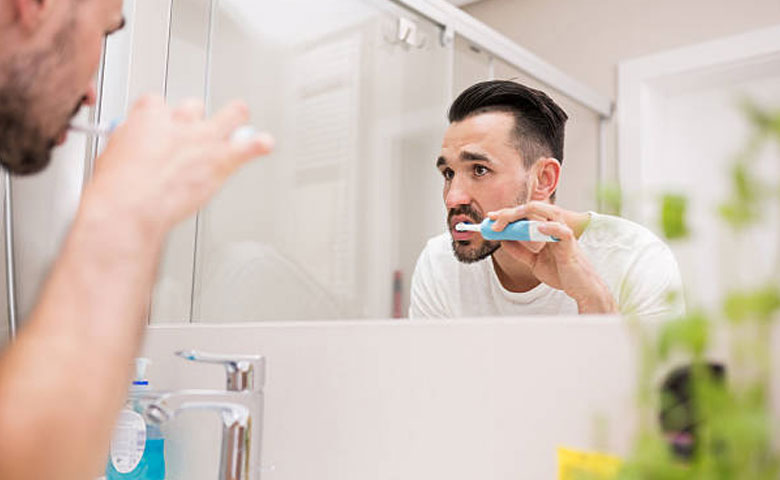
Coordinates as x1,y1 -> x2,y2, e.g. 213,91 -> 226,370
660,75 -> 780,308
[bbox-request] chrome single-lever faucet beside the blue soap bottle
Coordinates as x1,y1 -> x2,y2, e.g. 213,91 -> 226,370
144,350 -> 265,480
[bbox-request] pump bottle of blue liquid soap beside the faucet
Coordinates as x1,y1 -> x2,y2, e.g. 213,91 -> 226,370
106,358 -> 165,480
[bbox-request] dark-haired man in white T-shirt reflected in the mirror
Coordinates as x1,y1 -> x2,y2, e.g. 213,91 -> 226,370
409,81 -> 683,318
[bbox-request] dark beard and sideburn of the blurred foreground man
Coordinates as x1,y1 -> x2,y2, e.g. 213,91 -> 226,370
0,12 -> 84,175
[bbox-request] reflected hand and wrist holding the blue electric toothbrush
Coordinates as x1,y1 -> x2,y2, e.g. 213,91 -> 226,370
488,202 -> 618,313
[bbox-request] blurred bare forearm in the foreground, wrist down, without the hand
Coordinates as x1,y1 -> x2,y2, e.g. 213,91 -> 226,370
0,194 -> 168,479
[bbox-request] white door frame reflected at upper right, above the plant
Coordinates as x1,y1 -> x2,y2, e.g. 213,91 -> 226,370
617,25 -> 780,223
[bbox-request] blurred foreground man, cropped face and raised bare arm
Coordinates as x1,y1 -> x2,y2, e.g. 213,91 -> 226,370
0,0 -> 272,480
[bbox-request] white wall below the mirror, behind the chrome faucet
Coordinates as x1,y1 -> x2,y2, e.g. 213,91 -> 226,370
143,317 -> 638,480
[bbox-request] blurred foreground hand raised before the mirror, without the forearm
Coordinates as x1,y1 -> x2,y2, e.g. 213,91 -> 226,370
84,96 -> 273,240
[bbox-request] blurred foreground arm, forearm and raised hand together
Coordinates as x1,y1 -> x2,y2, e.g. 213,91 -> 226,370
0,97 -> 278,480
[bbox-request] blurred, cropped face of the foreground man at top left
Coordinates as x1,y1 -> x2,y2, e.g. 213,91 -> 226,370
0,0 -> 124,174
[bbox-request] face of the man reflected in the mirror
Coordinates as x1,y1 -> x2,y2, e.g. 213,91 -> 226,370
436,112 -> 528,263
